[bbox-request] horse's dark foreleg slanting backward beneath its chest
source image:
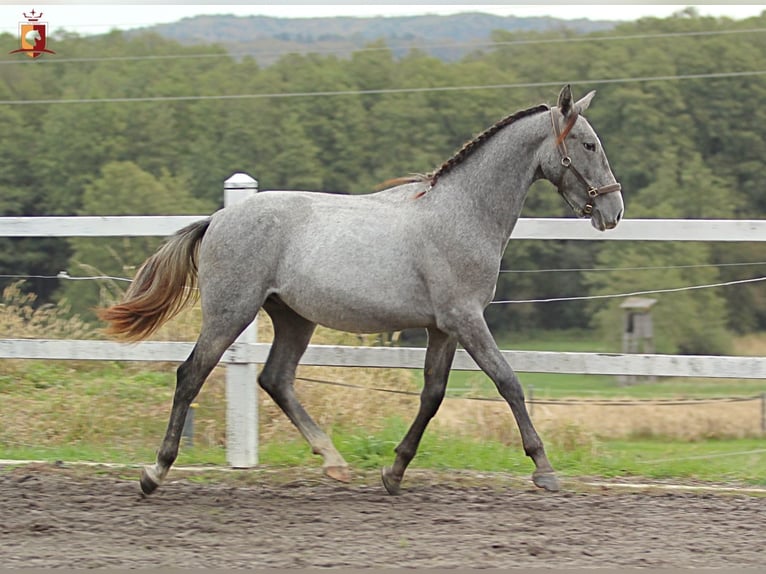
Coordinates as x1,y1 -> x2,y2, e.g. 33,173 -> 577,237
382,329 -> 457,494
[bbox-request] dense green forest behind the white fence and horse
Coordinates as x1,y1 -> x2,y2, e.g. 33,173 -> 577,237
0,9 -> 766,354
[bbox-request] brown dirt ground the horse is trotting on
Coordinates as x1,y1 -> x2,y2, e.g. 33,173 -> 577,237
0,465 -> 766,569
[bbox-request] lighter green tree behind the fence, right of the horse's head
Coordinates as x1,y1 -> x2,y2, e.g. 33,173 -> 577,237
587,150 -> 734,354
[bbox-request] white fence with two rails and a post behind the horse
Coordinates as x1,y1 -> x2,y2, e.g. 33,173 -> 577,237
0,174 -> 766,468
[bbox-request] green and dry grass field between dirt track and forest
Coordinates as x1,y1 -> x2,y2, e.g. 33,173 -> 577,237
0,286 -> 766,485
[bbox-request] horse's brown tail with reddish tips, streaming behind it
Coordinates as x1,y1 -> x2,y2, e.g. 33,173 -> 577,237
97,218 -> 210,341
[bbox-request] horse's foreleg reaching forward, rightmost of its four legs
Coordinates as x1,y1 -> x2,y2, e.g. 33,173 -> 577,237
454,314 -> 560,492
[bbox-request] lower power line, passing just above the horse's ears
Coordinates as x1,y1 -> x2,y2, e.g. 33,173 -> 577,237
0,70 -> 766,106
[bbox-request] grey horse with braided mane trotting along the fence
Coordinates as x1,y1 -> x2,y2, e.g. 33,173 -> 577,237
98,84 -> 624,495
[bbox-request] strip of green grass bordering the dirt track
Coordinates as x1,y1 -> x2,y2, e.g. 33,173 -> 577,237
0,419 -> 766,486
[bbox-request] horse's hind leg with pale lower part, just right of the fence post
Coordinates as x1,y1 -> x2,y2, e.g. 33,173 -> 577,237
258,299 -> 351,482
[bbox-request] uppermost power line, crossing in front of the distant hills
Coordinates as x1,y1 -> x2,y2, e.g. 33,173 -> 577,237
0,28 -> 766,65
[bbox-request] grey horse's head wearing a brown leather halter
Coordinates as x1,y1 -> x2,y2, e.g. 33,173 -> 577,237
540,85 -> 624,231
